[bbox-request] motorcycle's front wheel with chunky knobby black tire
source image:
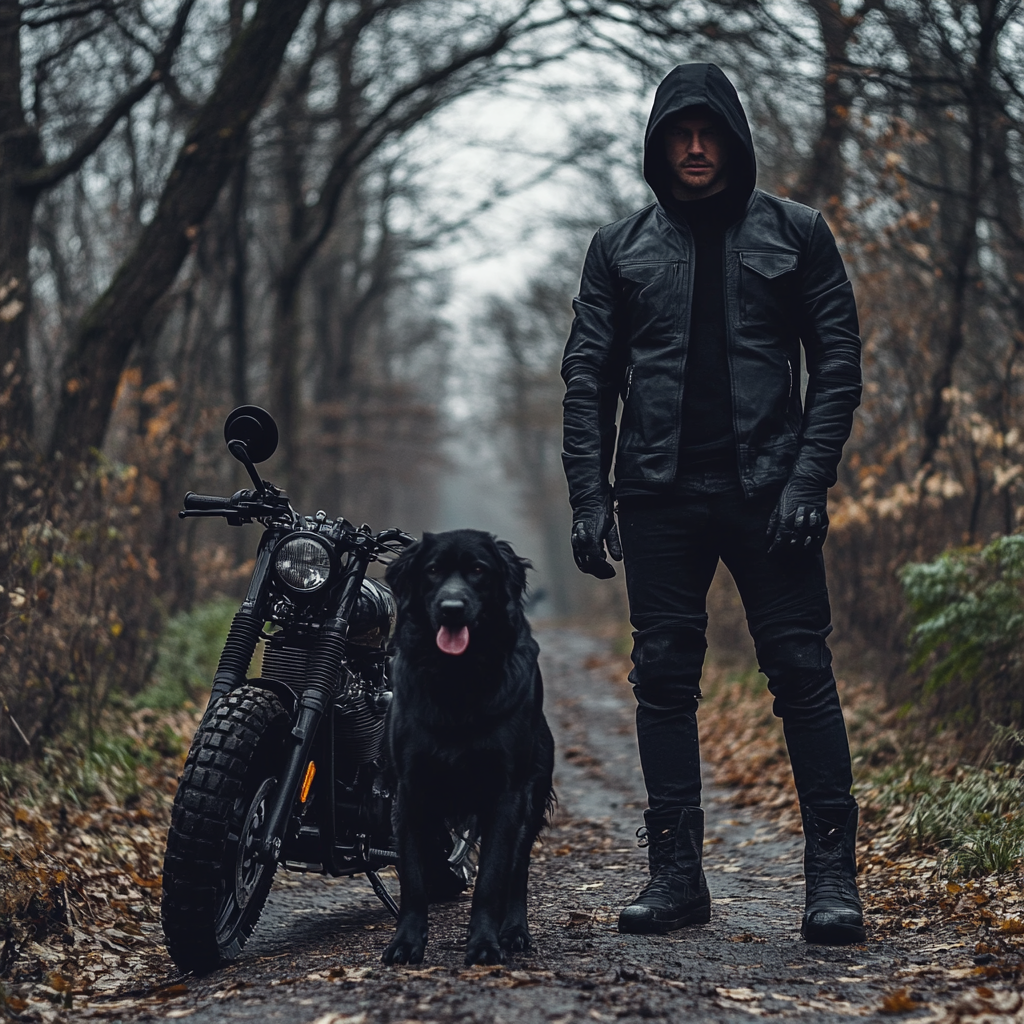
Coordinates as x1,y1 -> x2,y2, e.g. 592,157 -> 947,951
161,686 -> 290,973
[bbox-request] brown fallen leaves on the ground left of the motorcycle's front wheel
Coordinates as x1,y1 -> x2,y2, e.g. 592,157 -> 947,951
0,710 -> 200,1021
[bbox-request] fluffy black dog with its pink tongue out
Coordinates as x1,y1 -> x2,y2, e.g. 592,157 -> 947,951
384,529 -> 554,964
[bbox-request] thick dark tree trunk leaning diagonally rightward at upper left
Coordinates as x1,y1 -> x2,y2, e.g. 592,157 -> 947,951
51,0 -> 309,463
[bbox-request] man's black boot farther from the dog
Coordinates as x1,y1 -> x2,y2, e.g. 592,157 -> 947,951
800,806 -> 864,946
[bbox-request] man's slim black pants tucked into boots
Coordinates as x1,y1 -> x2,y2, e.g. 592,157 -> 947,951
618,490 -> 854,821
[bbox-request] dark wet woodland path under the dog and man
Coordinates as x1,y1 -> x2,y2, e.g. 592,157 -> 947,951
86,631 -> 973,1024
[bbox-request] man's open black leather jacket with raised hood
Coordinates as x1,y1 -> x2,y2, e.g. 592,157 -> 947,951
562,63 -> 860,510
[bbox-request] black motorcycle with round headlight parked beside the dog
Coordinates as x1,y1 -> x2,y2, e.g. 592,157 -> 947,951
162,406 -> 475,972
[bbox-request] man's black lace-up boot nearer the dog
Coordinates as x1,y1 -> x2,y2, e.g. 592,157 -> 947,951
618,807 -> 711,935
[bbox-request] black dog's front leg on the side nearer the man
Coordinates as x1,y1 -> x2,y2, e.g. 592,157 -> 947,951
466,794 -> 523,964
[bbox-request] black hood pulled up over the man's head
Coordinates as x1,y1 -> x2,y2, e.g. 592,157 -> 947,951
643,63 -> 757,204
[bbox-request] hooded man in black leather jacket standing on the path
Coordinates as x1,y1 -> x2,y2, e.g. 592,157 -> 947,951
562,65 -> 864,943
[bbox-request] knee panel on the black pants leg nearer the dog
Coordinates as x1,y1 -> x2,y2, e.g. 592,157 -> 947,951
629,626 -> 708,711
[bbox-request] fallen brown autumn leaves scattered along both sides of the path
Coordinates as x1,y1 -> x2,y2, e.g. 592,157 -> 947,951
0,638 -> 1024,1024
